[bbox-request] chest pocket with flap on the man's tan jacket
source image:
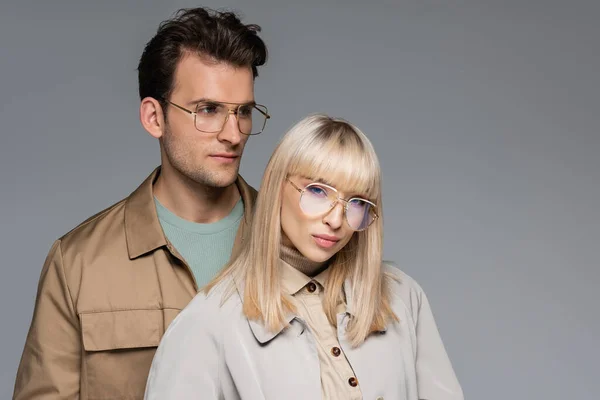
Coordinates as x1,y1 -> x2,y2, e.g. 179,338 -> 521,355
80,310 -> 178,399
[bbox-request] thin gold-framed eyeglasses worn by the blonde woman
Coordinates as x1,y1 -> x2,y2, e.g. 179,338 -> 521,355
286,178 -> 379,231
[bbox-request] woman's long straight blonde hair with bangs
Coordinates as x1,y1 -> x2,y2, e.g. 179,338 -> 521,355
204,114 -> 398,346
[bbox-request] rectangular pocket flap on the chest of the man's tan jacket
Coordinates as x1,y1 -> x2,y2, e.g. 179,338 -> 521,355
80,310 -> 164,351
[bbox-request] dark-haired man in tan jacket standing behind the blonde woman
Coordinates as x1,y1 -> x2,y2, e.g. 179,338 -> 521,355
13,8 -> 268,399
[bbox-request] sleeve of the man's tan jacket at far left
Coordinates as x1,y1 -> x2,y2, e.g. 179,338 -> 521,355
13,241 -> 81,400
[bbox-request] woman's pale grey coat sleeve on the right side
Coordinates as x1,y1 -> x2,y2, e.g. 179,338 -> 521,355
416,288 -> 464,400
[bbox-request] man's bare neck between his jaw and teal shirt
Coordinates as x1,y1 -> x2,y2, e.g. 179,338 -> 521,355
153,165 -> 240,224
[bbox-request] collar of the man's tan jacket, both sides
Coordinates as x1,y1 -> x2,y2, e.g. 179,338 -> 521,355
125,167 -> 256,260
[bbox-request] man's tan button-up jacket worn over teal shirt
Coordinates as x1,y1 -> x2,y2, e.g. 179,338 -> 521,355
13,168 -> 256,400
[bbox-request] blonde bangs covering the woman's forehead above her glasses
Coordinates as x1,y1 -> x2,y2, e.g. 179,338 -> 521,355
288,124 -> 380,201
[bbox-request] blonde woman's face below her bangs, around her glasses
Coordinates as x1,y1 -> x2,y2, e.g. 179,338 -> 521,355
281,176 -> 357,262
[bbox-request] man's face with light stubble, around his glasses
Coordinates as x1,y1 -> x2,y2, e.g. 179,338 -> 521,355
161,54 -> 254,188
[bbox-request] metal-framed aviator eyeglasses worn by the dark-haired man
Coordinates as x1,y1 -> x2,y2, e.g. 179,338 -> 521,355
166,100 -> 271,135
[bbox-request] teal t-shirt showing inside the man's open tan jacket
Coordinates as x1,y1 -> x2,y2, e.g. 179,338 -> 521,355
154,197 -> 244,288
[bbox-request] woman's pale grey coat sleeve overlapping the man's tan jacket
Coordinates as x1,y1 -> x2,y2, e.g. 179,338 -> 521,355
144,294 -> 223,400
